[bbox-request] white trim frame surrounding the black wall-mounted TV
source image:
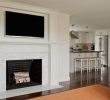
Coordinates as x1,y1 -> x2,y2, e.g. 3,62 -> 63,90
0,7 -> 49,42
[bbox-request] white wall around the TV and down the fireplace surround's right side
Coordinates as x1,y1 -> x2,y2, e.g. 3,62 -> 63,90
0,2 -> 69,85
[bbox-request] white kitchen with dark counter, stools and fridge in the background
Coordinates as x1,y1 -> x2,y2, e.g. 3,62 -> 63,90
70,25 -> 108,83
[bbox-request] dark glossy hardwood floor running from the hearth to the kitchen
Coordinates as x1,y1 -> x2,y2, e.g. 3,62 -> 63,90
5,67 -> 110,100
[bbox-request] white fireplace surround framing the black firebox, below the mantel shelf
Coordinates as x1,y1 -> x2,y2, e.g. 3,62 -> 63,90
0,44 -> 49,92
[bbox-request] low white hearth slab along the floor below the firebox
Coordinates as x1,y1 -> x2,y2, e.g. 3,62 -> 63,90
0,85 -> 63,99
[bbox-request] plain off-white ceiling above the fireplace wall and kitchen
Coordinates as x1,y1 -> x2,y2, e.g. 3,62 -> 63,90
3,0 -> 110,29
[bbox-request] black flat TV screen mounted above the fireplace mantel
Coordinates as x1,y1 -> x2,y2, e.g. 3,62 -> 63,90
6,11 -> 44,38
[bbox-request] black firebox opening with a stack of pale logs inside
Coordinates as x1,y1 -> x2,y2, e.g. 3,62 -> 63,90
6,59 -> 42,90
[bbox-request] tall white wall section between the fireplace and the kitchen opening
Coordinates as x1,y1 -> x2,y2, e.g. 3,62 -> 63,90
50,13 -> 70,85
